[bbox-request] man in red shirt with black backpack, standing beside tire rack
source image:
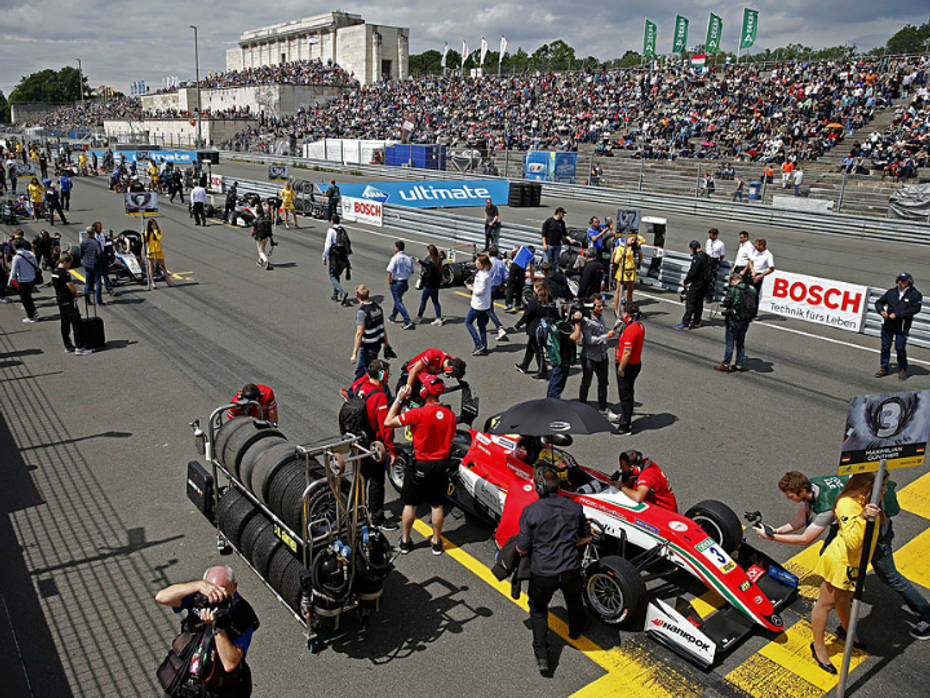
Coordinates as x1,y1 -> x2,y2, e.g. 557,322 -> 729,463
351,359 -> 398,531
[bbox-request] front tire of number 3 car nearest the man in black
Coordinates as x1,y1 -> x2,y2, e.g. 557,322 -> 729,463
584,555 -> 646,625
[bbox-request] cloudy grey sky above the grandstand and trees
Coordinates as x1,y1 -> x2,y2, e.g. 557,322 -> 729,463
0,0 -> 930,95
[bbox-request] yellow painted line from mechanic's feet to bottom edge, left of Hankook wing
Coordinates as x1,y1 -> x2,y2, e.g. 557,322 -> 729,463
413,519 -> 703,698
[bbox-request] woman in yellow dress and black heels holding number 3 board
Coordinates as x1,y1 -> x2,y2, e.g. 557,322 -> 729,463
811,473 -> 888,674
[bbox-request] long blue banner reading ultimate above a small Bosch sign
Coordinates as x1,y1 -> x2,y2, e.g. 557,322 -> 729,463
339,179 -> 510,208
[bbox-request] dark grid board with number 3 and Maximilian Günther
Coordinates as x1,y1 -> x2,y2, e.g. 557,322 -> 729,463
837,390 -> 930,475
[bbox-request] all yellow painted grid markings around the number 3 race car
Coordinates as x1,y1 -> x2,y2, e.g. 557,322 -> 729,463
414,473 -> 930,698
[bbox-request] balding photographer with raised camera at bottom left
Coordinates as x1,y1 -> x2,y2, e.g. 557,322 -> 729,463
155,566 -> 259,698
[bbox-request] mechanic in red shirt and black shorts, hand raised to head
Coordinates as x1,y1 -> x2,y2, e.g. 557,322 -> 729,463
384,373 -> 455,555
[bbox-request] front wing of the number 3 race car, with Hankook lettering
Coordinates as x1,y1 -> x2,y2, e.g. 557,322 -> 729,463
645,541 -> 798,671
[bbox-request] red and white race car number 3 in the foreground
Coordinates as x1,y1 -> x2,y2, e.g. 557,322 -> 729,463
389,426 -> 797,669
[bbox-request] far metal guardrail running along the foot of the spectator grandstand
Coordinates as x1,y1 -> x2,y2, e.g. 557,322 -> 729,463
221,151 -> 930,245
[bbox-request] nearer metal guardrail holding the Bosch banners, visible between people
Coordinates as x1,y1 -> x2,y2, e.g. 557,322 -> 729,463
225,170 -> 930,349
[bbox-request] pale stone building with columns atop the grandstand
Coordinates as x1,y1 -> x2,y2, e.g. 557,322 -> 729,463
226,11 -> 410,85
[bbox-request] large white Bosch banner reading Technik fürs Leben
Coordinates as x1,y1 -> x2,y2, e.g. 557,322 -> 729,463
759,269 -> 868,332
